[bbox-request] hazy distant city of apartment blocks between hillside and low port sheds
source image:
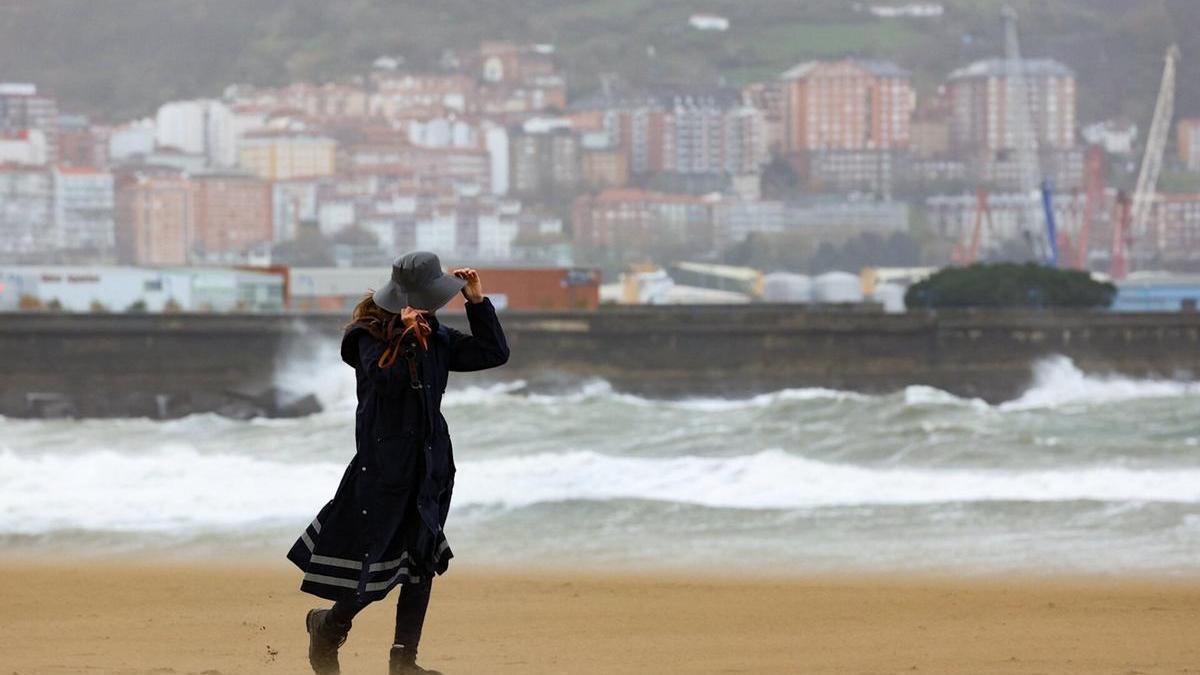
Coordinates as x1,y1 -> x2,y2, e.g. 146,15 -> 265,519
0,11 -> 1200,309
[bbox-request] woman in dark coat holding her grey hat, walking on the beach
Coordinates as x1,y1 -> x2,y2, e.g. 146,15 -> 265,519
288,251 -> 509,674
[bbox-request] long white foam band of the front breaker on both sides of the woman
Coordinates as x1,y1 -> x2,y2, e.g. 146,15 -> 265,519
0,446 -> 1200,534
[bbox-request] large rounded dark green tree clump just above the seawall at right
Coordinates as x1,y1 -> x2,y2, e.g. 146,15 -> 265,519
905,263 -> 1117,309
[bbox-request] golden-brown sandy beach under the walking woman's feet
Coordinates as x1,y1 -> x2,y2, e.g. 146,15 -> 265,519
0,561 -> 1200,675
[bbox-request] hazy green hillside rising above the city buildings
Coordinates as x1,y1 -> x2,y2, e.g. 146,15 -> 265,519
0,0 -> 1200,121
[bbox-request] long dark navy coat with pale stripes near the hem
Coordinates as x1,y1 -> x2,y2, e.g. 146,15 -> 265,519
288,298 -> 509,601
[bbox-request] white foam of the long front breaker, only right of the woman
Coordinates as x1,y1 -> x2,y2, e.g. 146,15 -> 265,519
460,450 -> 1200,509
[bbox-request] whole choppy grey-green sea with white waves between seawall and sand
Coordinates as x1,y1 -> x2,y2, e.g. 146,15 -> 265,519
0,350 -> 1200,574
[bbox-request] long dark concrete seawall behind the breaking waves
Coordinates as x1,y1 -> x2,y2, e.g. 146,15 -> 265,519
0,305 -> 1200,417
